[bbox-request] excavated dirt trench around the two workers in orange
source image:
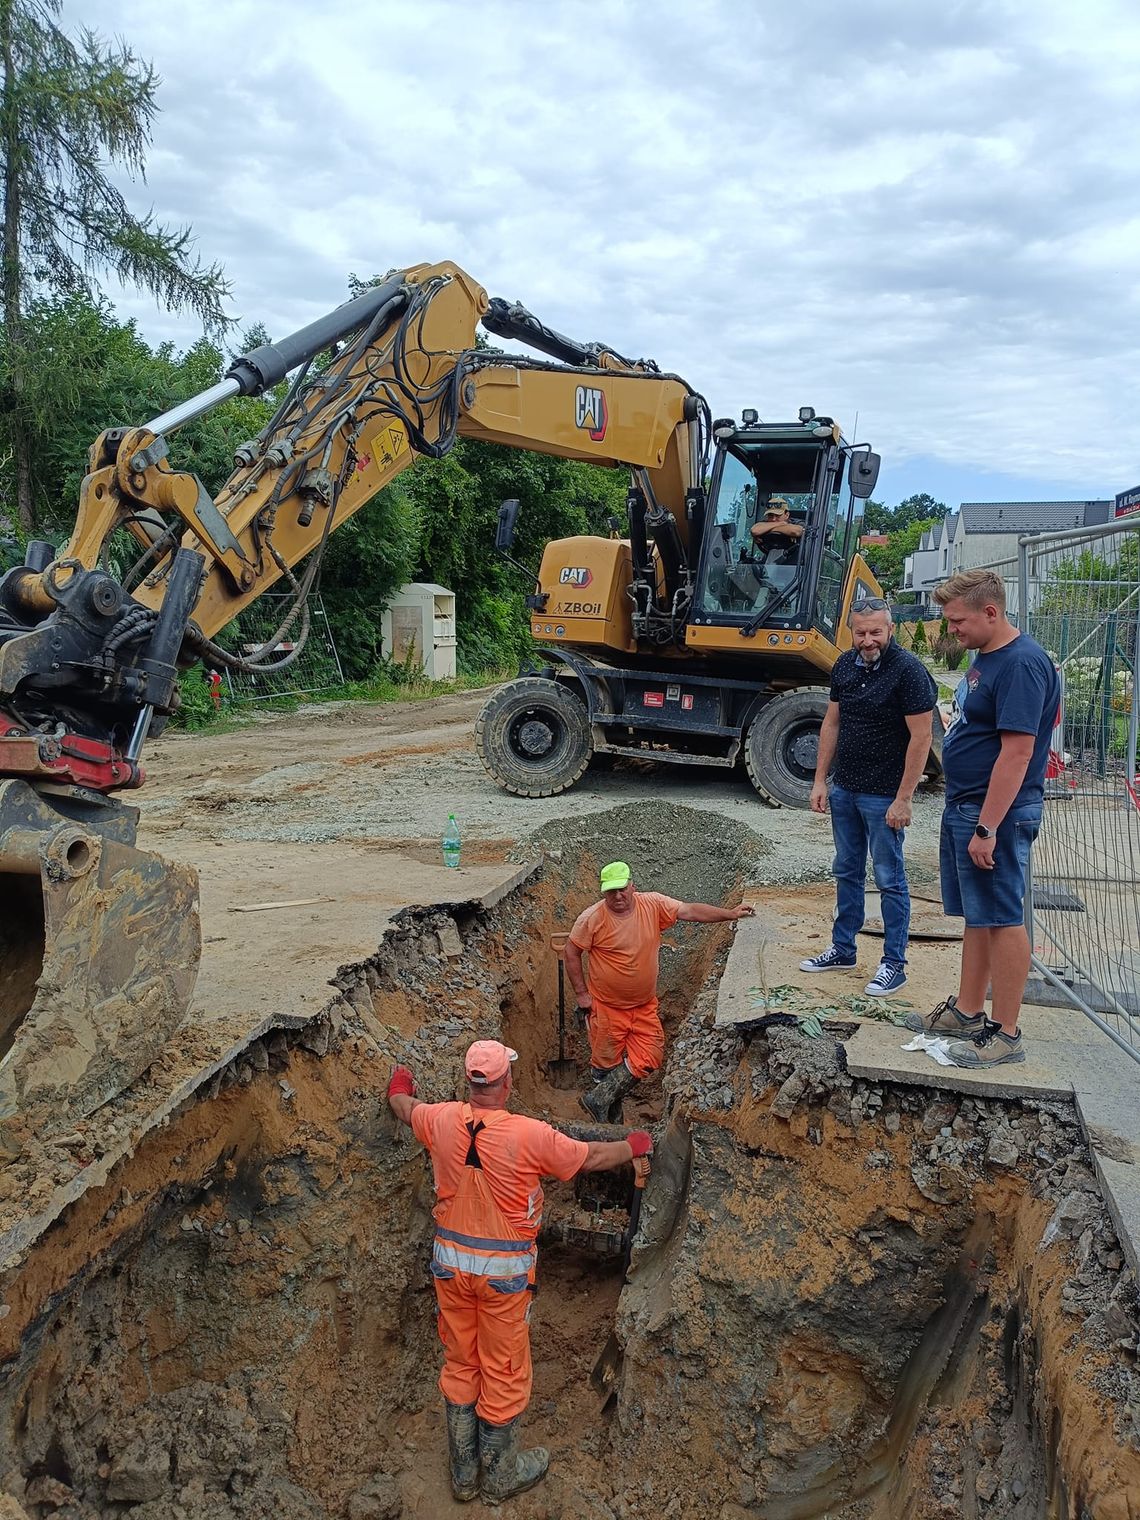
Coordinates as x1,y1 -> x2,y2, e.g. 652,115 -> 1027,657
0,806 -> 1140,1520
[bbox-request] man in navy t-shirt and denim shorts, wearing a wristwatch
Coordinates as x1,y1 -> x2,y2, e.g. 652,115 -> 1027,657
907,570 -> 1061,1066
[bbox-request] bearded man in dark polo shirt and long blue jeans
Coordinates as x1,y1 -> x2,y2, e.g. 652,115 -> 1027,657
800,597 -> 938,997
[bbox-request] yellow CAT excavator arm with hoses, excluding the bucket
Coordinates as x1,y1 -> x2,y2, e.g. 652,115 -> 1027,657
0,264 -> 705,792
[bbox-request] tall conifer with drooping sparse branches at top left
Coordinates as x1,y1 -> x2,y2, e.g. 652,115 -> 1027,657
0,0 -> 230,529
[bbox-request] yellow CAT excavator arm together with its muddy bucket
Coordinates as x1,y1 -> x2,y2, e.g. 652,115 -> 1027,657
0,263 -> 708,1140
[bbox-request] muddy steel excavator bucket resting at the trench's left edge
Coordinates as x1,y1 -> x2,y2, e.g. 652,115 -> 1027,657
0,780 -> 202,1135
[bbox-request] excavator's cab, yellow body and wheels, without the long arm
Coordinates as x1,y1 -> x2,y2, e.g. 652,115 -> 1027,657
476,404 -> 881,807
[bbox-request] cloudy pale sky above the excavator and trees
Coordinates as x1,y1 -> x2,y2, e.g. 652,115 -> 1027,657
76,0 -> 1140,506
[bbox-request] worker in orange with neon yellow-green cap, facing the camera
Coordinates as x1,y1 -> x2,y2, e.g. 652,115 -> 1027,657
565,860 -> 755,1123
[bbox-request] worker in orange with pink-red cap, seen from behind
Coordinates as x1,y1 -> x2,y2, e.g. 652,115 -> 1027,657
388,1040 -> 652,1505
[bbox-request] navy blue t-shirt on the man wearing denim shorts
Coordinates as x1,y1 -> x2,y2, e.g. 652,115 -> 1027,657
942,634 -> 1061,807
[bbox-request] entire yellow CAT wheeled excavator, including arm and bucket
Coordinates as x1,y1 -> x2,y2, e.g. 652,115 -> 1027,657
0,263 -> 877,1140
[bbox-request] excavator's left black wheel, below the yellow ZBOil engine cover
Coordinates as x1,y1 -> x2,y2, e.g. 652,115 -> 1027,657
476,675 -> 591,796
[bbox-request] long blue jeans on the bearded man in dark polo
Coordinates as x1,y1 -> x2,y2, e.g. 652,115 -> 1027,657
831,784 -> 910,965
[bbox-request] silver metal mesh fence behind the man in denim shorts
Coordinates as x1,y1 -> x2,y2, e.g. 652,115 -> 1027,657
994,518 -> 1140,1061
